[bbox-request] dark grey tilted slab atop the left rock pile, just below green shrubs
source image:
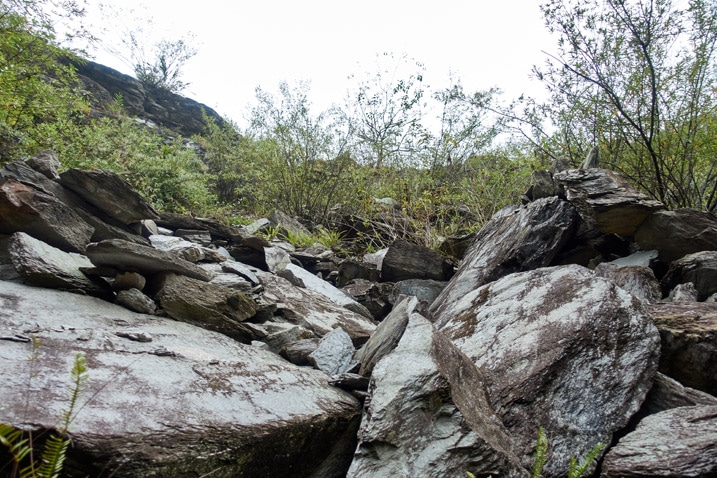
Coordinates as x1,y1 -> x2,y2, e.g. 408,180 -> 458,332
60,169 -> 159,224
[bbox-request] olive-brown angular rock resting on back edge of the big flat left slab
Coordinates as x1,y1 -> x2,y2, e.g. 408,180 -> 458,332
152,272 -> 257,341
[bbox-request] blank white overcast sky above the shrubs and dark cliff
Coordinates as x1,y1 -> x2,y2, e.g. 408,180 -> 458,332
81,0 -> 555,126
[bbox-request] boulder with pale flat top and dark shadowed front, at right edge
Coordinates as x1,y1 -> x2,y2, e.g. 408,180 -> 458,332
648,302 -> 717,395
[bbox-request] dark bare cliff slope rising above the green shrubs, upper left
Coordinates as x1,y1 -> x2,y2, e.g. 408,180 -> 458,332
75,61 -> 223,136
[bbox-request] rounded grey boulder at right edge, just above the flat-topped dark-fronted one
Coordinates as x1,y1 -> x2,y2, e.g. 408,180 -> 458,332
661,250 -> 717,301
